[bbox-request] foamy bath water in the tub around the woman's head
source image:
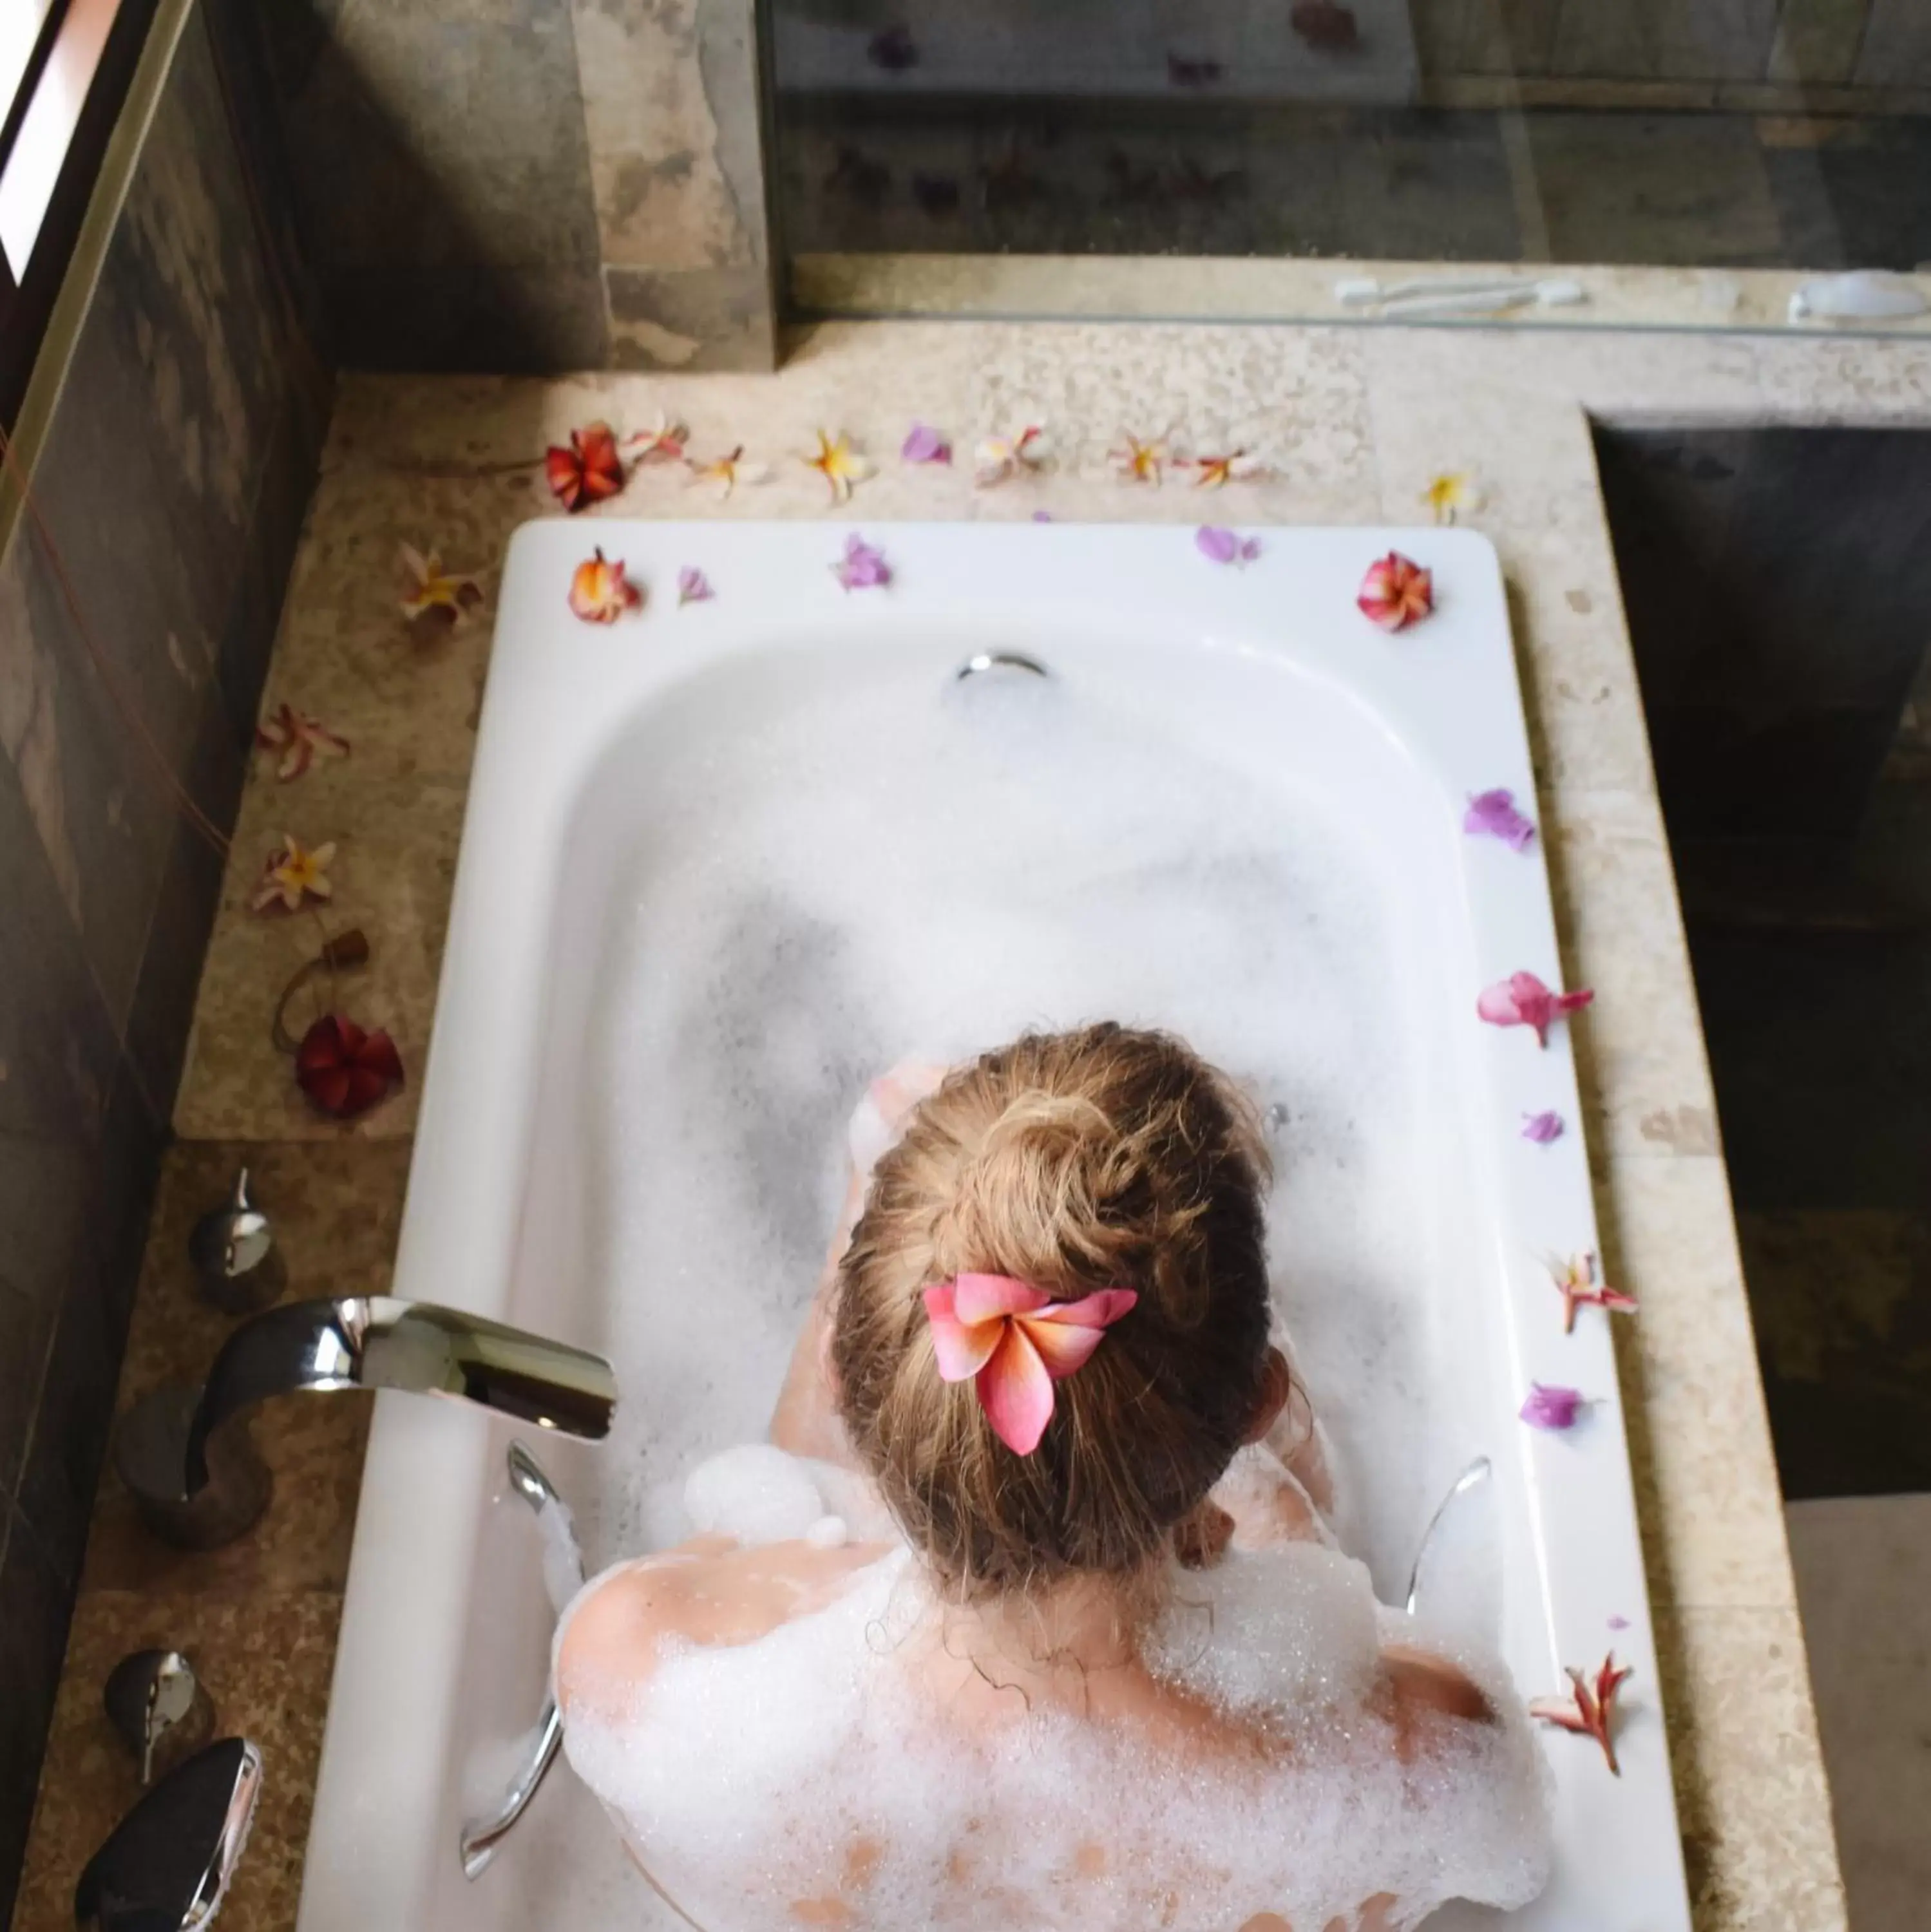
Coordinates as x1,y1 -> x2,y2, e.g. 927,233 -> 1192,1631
576,676 -> 1467,1596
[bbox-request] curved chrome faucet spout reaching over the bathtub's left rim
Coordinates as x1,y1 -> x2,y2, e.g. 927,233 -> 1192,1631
114,1294 -> 616,1549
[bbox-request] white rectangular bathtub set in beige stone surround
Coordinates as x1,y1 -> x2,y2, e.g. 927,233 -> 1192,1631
298,520 -> 1689,1932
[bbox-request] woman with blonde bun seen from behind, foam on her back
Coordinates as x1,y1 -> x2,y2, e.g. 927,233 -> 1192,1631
556,1026 -> 1546,1932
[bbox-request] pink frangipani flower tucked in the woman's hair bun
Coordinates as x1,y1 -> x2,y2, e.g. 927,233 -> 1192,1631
924,1275 -> 1139,1455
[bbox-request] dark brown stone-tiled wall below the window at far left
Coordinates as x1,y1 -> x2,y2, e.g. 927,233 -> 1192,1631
0,6 -> 328,1901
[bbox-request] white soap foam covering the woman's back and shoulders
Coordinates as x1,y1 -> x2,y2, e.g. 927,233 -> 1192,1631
564,1445 -> 1548,1932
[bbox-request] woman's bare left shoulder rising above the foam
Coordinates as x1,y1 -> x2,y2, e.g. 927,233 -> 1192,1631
556,1536 -> 889,1716
